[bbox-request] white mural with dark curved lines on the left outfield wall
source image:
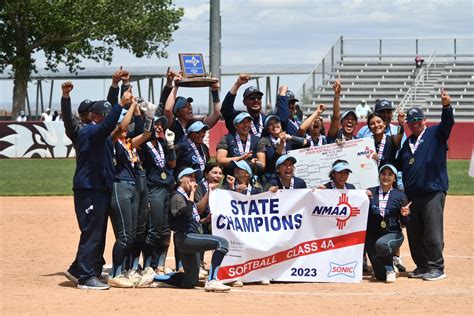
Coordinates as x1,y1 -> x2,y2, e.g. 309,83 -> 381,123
0,122 -> 75,158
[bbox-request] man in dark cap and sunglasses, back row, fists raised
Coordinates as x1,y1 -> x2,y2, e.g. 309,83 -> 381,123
221,74 -> 289,137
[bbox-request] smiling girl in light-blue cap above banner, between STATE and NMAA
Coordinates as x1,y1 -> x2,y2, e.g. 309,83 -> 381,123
267,155 -> 306,192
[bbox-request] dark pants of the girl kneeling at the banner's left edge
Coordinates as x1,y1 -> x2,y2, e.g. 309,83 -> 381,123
174,232 -> 229,288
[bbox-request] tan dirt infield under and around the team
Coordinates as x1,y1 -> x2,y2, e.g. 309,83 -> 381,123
0,196 -> 474,315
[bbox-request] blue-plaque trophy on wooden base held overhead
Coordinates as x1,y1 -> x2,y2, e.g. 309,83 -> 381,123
176,53 -> 217,88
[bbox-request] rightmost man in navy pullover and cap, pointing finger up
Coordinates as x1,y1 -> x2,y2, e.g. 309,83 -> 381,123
398,90 -> 454,281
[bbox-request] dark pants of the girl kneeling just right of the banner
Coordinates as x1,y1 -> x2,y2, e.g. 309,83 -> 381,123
365,232 -> 404,281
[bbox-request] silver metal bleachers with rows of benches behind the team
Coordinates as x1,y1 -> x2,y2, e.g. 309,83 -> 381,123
304,57 -> 474,120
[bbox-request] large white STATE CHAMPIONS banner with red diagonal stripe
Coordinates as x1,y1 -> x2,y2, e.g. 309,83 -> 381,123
209,189 -> 369,283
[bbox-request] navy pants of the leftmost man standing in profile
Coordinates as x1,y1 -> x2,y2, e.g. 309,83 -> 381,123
69,190 -> 110,283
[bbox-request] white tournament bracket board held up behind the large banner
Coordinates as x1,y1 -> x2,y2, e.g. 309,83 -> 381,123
288,138 -> 379,189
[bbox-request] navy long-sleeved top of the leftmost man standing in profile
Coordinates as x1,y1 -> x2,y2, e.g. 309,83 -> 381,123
73,104 -> 122,192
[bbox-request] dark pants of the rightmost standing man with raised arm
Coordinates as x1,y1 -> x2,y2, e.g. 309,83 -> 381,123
407,192 -> 446,272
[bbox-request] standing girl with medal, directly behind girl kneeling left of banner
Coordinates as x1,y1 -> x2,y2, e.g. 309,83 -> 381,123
142,116 -> 176,273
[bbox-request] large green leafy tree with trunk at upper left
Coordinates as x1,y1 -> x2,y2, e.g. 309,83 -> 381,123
0,0 -> 183,117
